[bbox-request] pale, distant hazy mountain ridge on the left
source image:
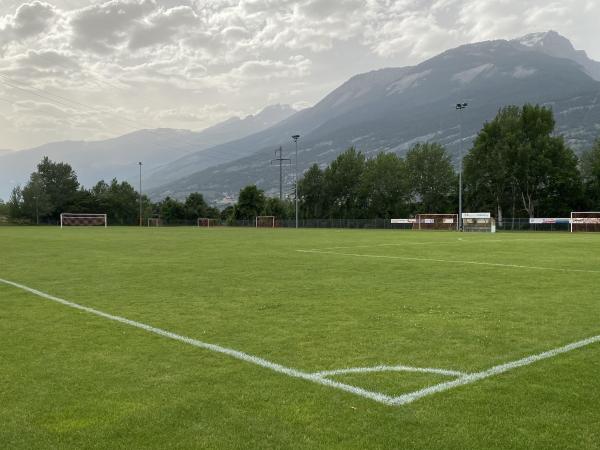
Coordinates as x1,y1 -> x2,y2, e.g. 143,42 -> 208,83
0,105 -> 296,198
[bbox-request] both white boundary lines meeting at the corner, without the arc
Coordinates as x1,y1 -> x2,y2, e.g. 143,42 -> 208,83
0,278 -> 600,406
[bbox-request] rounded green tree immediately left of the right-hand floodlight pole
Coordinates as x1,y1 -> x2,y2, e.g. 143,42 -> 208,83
406,143 -> 458,213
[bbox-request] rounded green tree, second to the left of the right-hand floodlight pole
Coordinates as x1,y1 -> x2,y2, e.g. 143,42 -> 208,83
360,153 -> 410,219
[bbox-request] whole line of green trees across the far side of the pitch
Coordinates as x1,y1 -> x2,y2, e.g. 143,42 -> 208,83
0,105 -> 600,225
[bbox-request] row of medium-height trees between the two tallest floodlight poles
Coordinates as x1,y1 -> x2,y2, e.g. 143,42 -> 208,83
298,143 -> 458,219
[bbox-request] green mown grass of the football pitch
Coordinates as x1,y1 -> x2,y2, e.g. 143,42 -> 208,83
0,227 -> 600,449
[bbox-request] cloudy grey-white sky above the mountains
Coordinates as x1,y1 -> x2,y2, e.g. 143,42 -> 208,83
0,0 -> 600,149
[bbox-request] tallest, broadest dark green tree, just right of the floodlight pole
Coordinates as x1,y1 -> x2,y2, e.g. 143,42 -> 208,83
465,105 -> 582,221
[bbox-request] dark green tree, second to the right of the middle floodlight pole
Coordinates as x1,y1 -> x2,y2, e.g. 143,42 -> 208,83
323,147 -> 365,219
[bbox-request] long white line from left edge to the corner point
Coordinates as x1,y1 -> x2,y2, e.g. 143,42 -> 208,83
0,278 -> 393,405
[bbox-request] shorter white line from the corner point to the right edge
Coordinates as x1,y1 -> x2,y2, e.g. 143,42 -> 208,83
393,335 -> 600,405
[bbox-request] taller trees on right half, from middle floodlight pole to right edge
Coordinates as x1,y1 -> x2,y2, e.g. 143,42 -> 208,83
299,105 -> 600,221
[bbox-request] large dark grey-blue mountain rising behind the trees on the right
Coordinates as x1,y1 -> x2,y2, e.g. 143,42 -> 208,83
152,33 -> 600,204
